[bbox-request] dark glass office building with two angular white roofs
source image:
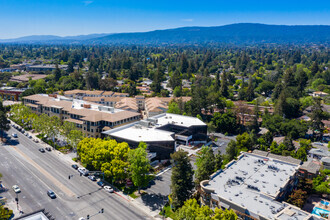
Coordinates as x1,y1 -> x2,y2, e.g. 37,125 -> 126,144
103,113 -> 207,159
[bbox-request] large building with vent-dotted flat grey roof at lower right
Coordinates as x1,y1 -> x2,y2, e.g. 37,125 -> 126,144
201,152 -> 319,219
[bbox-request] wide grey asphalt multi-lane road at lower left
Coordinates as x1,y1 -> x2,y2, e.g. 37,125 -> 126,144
0,129 -> 151,220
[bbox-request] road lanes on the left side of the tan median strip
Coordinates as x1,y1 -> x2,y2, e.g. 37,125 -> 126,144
0,146 -> 73,219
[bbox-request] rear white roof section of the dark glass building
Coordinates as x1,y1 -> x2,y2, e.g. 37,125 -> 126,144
152,113 -> 206,127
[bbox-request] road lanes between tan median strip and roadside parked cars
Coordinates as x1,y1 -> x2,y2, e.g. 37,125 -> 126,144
8,129 -> 150,219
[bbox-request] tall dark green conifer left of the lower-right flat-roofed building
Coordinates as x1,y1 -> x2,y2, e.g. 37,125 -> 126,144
170,150 -> 194,208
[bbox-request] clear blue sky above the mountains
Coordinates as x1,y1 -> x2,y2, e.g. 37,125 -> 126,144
0,0 -> 330,39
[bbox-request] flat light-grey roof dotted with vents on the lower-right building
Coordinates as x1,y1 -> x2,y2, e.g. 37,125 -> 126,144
207,153 -> 298,219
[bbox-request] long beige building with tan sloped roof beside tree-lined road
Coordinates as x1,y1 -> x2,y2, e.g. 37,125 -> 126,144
23,94 -> 140,138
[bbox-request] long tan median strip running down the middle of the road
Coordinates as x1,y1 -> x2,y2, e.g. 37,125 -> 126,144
11,145 -> 76,197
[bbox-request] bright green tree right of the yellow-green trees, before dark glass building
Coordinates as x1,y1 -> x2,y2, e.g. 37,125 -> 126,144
128,142 -> 150,193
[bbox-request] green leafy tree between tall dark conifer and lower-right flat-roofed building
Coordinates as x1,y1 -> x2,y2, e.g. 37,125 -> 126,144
195,146 -> 215,187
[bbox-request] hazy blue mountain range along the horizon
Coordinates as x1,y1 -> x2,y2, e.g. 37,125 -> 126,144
0,23 -> 330,45
